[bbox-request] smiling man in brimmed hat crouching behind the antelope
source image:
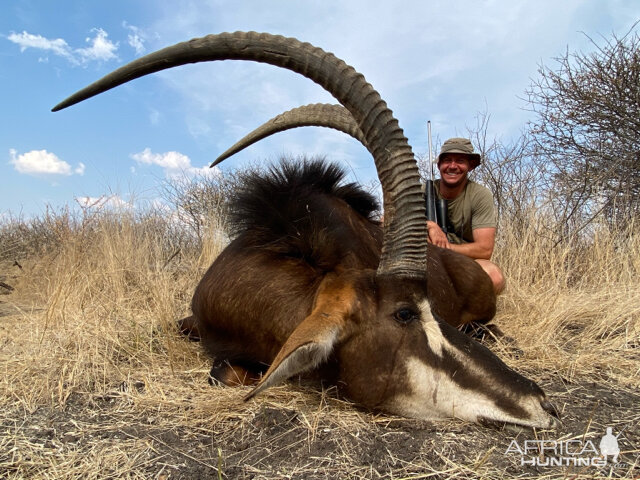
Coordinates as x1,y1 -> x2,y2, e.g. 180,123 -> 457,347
427,138 -> 505,293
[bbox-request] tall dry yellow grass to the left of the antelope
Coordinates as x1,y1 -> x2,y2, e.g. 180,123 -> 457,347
0,204 -> 222,409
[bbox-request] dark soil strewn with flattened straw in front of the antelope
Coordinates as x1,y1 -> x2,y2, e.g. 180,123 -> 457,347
0,381 -> 640,479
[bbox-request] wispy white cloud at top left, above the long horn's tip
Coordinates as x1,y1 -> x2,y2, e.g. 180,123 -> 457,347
7,28 -> 118,65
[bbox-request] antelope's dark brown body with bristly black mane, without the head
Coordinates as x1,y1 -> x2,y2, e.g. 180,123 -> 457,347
182,163 -> 496,383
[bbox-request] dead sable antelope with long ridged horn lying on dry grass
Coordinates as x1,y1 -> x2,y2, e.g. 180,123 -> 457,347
54,32 -> 557,427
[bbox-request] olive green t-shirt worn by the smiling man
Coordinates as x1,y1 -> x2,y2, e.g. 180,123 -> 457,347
434,180 -> 497,244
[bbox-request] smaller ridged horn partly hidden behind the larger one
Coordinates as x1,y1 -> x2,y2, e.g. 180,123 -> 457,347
211,103 -> 368,167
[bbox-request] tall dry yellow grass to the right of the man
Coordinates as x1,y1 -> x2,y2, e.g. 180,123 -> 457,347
494,215 -> 640,386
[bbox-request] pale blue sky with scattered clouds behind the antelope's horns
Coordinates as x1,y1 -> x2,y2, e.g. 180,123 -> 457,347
0,0 -> 640,216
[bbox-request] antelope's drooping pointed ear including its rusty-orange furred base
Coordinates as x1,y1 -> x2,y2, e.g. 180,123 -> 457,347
244,276 -> 356,401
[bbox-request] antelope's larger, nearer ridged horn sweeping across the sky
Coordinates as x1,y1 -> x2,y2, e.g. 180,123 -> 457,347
53,32 -> 427,277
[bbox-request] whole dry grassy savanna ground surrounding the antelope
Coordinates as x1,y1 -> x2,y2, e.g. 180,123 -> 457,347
0,196 -> 640,479
